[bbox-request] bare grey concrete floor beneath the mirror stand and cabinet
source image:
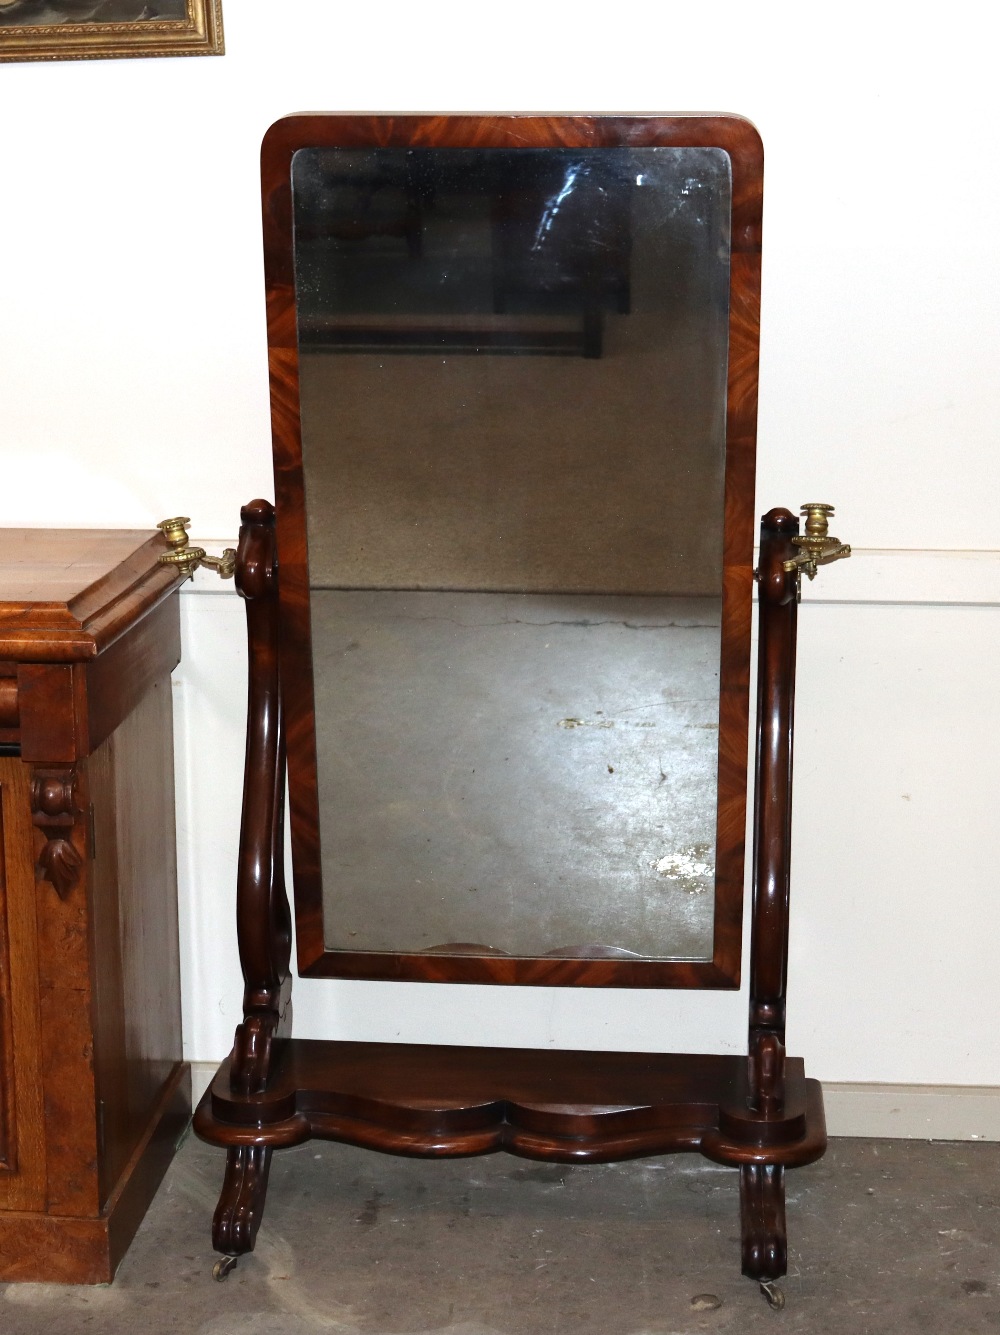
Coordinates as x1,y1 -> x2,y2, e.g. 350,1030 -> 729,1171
0,1139 -> 1000,1335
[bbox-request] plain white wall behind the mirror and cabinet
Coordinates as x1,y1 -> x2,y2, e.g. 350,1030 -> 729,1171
0,0 -> 1000,1085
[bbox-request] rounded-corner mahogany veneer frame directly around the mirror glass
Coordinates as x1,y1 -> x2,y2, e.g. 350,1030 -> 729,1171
262,113 -> 764,989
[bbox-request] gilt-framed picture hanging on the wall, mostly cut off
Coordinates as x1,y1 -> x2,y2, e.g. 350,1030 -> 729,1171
0,0 -> 226,61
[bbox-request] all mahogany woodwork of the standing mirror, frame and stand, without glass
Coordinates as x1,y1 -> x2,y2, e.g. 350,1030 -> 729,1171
195,116 -> 826,1280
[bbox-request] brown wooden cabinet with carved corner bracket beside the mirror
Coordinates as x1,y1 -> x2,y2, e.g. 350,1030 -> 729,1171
0,530 -> 191,1283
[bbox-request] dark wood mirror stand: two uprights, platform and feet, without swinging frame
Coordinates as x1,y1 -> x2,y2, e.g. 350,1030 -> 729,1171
195,502 -> 826,1282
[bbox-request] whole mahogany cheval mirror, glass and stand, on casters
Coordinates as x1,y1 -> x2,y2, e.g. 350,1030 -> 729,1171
195,115 -> 848,1304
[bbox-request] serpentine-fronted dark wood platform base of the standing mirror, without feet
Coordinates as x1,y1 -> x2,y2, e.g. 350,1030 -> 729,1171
195,1039 -> 826,1165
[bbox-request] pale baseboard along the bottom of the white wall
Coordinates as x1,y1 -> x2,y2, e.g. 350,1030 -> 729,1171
191,1061 -> 1000,1140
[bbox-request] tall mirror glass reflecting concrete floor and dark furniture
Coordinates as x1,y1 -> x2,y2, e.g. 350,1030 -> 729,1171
292,148 -> 730,960
